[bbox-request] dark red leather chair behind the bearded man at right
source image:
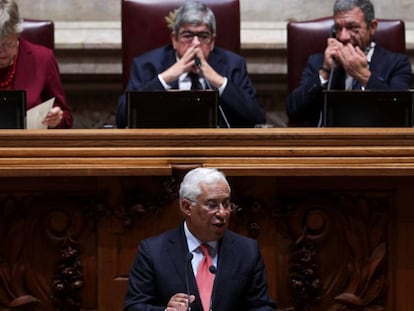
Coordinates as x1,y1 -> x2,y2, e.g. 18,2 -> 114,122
287,17 -> 405,92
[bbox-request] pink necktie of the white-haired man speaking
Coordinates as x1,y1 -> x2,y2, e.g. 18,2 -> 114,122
196,244 -> 214,311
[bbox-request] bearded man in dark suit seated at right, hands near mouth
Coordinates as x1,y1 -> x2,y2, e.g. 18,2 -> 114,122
286,0 -> 412,126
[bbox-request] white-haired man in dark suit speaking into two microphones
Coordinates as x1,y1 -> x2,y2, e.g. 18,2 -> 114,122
124,168 -> 276,311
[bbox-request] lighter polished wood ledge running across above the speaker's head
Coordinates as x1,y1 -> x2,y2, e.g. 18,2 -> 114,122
0,128 -> 414,176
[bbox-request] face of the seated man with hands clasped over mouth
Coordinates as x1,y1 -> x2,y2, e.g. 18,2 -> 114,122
171,25 -> 215,59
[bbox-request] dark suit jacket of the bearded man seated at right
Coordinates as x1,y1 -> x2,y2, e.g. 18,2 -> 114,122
286,44 -> 412,126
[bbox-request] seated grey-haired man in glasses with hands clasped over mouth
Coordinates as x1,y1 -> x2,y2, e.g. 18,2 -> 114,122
117,2 -> 265,127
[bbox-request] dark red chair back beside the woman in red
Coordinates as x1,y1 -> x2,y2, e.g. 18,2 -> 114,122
21,18 -> 55,50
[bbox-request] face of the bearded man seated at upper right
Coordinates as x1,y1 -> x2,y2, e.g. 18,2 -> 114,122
334,8 -> 377,51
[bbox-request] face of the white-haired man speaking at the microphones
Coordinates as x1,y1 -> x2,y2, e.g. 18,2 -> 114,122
182,181 -> 231,243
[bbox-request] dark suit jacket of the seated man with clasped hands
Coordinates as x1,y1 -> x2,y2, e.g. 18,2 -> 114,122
116,45 -> 266,128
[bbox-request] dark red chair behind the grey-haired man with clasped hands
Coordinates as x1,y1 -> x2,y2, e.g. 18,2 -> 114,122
121,0 -> 240,86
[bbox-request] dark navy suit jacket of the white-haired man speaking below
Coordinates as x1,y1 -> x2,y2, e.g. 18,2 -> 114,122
124,225 -> 275,311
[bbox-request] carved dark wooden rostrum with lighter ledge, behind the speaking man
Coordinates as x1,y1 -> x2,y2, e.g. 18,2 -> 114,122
0,128 -> 414,311
